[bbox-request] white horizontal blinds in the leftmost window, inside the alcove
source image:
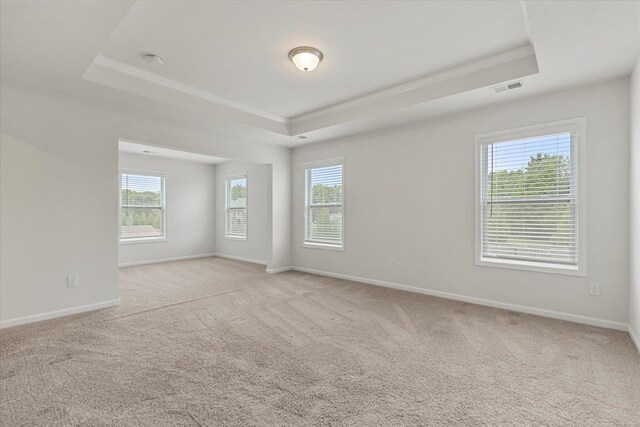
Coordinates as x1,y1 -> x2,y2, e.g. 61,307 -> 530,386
120,173 -> 164,239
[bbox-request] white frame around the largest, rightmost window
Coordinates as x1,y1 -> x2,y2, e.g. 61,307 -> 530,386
474,117 -> 587,276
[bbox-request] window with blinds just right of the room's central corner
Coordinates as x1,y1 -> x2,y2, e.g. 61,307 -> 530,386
304,160 -> 344,249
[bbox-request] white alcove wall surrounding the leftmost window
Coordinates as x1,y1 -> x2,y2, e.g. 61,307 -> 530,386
118,152 -> 215,265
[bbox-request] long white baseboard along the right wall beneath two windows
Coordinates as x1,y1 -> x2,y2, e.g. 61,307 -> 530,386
292,267 -> 637,332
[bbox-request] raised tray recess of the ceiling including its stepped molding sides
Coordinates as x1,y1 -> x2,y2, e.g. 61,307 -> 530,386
85,2 -> 538,135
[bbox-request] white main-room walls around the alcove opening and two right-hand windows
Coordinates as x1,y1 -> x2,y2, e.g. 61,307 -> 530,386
0,79 -> 637,332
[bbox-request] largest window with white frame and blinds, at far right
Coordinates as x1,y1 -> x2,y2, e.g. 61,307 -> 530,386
476,119 -> 586,275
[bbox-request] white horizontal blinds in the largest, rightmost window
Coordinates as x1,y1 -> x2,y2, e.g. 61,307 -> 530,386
481,132 -> 578,267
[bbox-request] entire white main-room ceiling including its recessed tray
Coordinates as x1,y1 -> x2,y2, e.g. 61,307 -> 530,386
0,0 -> 640,146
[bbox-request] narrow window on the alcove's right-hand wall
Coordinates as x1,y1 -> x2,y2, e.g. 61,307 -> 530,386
224,174 -> 247,240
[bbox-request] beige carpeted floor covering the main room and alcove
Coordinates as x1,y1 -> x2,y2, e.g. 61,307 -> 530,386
0,258 -> 640,426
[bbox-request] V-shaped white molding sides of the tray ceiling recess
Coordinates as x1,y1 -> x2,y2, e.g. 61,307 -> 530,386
83,44 -> 538,136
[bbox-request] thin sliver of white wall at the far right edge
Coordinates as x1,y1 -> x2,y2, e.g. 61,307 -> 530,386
629,59 -> 640,351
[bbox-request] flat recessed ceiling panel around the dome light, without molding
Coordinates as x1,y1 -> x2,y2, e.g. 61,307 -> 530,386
100,1 -> 528,118
